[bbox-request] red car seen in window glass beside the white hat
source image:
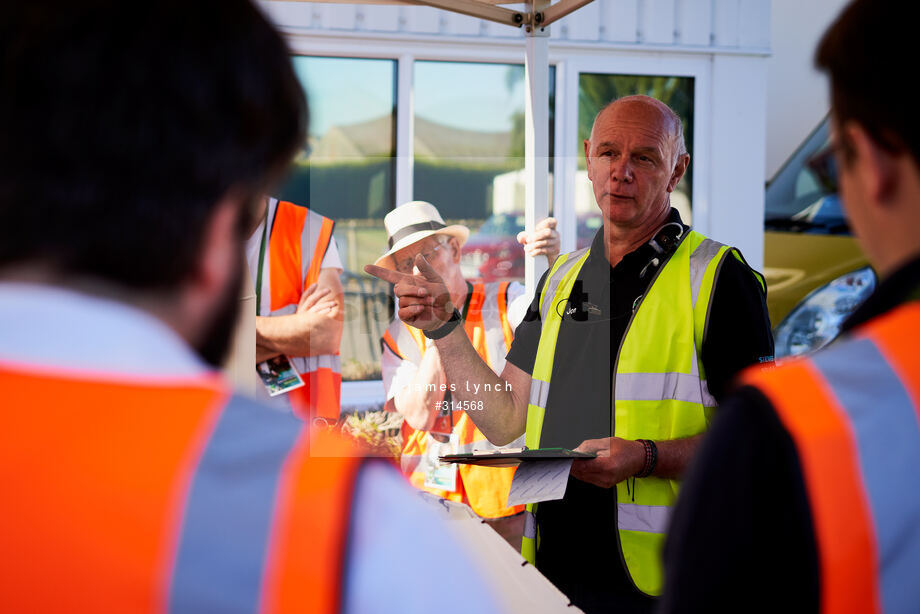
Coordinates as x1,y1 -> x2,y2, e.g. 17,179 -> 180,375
460,213 -> 601,281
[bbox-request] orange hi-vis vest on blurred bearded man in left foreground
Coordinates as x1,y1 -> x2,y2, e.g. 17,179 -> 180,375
0,363 -> 362,613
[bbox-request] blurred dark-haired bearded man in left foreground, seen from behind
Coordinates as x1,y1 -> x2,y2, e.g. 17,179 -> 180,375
0,0 -> 494,612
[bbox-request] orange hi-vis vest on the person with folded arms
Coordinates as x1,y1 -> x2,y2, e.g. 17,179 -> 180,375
260,199 -> 342,420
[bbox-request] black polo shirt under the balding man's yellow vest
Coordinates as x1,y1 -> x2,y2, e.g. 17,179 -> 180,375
507,209 -> 773,612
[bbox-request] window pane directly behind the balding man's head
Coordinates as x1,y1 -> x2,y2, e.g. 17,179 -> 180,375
575,73 -> 693,243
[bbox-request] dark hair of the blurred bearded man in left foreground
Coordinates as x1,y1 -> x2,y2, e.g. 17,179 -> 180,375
0,0 -> 307,290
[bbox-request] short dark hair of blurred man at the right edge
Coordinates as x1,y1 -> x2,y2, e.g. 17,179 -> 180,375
815,0 -> 920,163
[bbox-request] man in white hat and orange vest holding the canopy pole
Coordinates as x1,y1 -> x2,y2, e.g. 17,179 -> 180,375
375,201 -> 559,545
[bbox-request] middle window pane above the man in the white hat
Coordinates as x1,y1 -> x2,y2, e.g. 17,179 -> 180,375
414,62 -> 555,281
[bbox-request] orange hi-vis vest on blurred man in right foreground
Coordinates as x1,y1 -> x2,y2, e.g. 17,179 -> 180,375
742,302 -> 920,614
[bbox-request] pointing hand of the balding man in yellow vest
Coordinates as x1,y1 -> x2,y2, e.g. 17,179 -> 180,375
364,254 -> 454,330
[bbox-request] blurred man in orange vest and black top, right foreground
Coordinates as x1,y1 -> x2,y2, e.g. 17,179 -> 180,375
663,0 -> 920,613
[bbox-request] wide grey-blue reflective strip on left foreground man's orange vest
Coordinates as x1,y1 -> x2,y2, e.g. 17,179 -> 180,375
169,397 -> 301,613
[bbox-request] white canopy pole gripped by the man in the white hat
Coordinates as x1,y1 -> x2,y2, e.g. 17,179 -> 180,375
524,0 -> 550,295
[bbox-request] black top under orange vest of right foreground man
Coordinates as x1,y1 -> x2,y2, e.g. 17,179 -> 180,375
661,259 -> 920,612
